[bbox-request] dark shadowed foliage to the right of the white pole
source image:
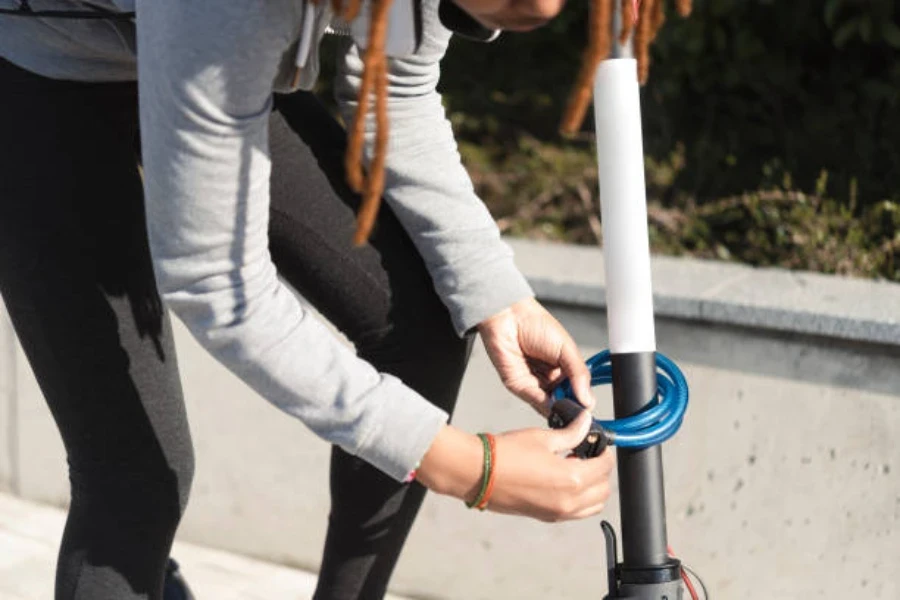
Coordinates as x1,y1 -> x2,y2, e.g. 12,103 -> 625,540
644,0 -> 900,207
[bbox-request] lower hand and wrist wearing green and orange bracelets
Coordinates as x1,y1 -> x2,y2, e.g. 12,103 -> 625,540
417,411 -> 615,522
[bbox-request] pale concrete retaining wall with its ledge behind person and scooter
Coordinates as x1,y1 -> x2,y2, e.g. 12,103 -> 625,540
0,242 -> 900,600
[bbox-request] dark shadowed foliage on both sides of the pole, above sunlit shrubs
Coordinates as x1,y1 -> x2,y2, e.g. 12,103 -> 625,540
443,0 -> 900,206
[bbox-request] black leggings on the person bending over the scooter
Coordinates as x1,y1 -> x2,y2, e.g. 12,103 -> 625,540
0,59 -> 471,600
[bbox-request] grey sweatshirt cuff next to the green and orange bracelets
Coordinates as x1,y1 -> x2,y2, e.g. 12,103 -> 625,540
353,374 -> 449,482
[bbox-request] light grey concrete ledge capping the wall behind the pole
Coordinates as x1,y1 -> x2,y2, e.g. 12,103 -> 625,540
507,239 -> 900,346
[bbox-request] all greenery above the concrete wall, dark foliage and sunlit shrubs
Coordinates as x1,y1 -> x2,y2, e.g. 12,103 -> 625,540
352,0 -> 900,281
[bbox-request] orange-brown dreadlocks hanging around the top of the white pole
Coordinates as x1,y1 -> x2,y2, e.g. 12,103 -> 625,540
560,0 -> 692,134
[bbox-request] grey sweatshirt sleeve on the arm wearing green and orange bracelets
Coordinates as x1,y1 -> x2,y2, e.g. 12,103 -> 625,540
137,0 -> 447,480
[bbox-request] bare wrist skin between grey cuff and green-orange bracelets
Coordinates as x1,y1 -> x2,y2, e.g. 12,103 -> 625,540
416,425 -> 484,502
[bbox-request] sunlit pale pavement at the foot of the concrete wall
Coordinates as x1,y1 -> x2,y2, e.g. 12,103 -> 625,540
0,494 -> 400,600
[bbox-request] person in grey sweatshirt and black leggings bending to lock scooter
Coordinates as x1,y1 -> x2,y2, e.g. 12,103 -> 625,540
0,0 -> 613,600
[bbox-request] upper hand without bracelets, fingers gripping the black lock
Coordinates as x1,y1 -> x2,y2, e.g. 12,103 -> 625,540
478,298 -> 595,416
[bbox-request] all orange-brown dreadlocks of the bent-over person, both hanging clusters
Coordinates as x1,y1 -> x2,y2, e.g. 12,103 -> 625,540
330,0 -> 691,246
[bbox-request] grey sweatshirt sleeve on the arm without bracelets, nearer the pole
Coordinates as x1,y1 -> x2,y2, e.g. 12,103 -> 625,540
335,0 -> 533,334
